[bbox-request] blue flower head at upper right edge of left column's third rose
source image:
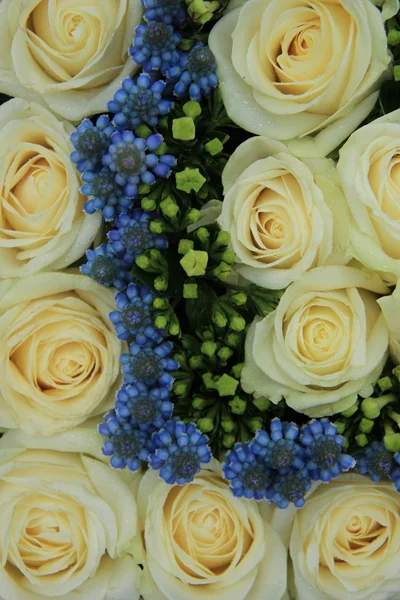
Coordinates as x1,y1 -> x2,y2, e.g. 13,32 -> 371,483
109,283 -> 162,346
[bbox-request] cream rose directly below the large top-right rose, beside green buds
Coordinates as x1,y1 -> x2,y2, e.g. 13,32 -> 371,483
219,137 -> 348,289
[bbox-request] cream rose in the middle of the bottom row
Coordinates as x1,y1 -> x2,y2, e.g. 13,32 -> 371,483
138,462 -> 287,600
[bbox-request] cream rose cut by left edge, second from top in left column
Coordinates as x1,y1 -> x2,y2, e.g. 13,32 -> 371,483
0,99 -> 101,277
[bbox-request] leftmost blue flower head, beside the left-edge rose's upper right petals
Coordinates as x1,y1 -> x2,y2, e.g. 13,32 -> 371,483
71,115 -> 115,173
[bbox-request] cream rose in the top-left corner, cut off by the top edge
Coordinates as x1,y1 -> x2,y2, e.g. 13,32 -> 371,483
0,0 -> 142,121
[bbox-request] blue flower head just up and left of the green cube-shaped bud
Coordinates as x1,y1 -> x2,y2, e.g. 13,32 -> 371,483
108,73 -> 174,129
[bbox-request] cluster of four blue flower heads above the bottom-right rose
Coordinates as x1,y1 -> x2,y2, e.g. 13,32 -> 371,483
223,419 -> 355,508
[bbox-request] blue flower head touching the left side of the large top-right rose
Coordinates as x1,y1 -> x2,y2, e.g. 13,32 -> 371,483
167,42 -> 218,102
